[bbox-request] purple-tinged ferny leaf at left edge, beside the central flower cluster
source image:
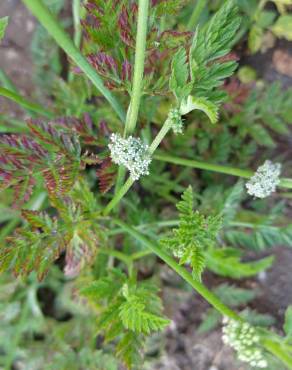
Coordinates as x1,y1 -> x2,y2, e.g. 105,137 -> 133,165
0,116 -> 101,205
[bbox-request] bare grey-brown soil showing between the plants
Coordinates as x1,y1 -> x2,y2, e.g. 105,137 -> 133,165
0,0 -> 292,370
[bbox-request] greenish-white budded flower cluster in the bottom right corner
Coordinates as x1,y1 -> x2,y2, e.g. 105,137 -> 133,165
222,318 -> 268,369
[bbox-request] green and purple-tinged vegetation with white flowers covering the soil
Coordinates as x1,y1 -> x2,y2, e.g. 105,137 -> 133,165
0,0 -> 292,370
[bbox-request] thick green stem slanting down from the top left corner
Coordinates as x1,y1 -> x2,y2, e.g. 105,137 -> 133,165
22,0 -> 125,121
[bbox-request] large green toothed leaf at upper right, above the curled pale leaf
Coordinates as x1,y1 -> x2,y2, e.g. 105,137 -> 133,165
189,0 -> 240,111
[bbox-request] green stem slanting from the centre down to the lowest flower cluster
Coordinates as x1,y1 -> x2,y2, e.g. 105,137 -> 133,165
112,219 -> 243,321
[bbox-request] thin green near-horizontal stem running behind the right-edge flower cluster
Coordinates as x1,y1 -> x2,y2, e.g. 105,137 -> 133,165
153,153 -> 292,189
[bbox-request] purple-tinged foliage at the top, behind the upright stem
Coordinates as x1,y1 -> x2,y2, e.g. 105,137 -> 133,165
82,0 -> 193,95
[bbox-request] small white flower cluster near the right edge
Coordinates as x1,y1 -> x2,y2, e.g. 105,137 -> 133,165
245,161 -> 281,198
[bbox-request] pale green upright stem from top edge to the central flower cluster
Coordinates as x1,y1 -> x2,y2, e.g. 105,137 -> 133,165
125,0 -> 149,136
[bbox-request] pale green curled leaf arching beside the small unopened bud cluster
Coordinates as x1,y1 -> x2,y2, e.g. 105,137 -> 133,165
180,95 -> 219,123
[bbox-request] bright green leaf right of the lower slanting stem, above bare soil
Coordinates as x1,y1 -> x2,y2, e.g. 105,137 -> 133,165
206,248 -> 274,279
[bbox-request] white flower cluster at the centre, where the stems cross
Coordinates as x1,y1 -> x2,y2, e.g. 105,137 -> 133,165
108,134 -> 151,180
